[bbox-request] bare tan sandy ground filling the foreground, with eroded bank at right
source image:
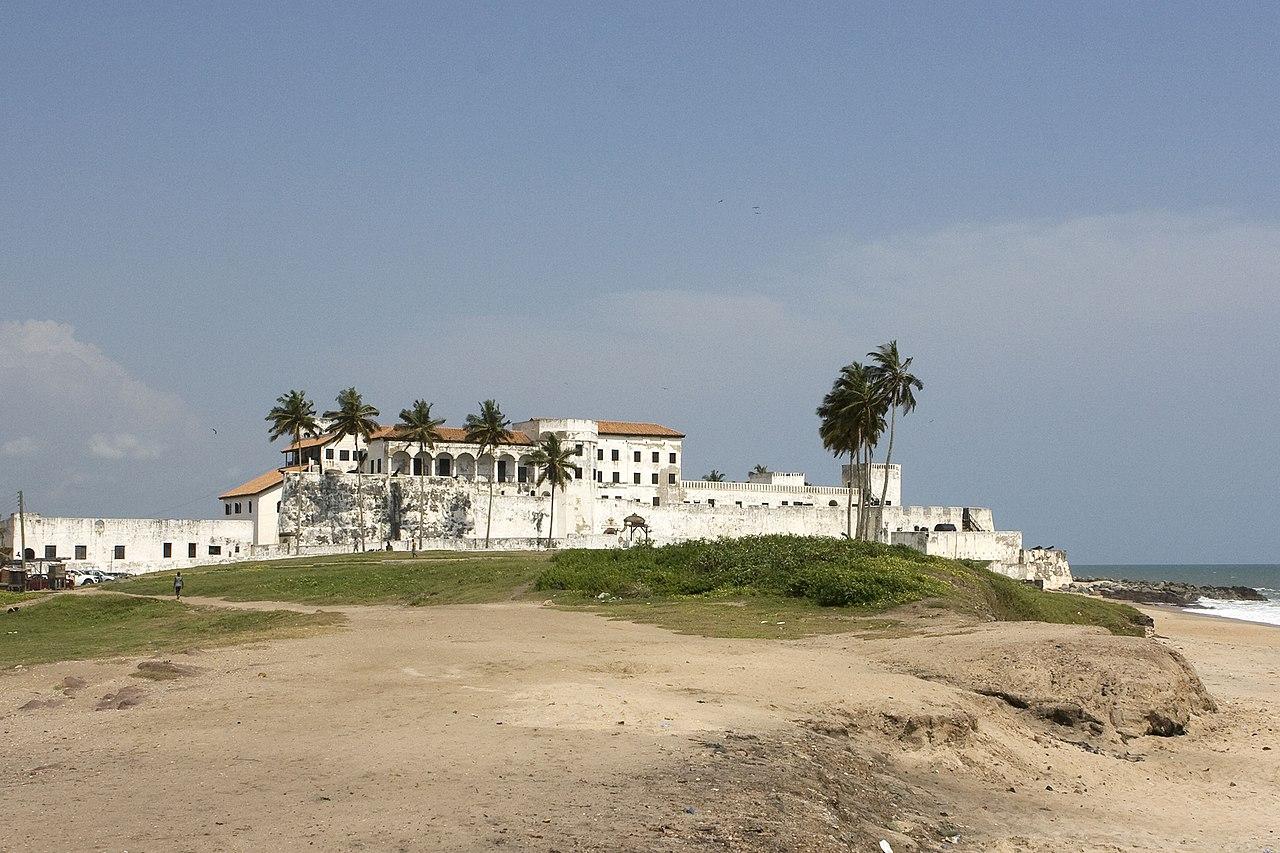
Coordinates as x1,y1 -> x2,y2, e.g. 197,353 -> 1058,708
0,603 -> 1280,853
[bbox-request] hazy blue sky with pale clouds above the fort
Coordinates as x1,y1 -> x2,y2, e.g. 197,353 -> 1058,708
0,1 -> 1280,564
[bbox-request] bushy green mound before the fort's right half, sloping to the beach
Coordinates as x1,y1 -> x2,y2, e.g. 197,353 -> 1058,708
536,535 -> 1144,637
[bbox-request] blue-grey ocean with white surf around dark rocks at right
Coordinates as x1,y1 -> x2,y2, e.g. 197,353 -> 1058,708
1071,564 -> 1280,625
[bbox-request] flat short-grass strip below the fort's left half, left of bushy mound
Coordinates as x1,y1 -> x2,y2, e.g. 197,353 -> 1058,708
110,551 -> 548,606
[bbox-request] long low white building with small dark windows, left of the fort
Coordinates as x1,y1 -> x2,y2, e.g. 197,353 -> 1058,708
0,512 -> 253,573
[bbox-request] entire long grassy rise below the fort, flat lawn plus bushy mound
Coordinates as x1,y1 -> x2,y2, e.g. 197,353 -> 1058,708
110,537 -> 1143,637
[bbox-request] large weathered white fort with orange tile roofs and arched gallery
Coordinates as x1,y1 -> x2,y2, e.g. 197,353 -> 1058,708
207,418 -> 1070,587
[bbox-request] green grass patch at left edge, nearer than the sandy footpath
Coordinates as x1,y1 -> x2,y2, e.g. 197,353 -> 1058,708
0,593 -> 344,669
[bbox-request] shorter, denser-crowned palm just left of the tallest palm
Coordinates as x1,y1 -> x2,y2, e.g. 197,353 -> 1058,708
818,361 -> 884,539
